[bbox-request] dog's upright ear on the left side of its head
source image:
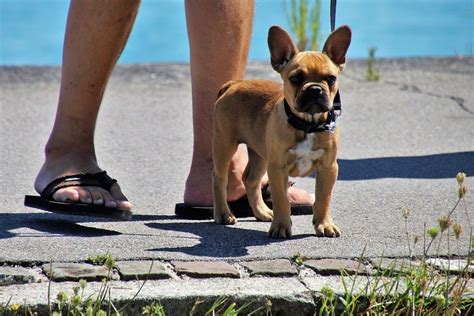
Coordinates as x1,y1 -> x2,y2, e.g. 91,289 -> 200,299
268,26 -> 298,72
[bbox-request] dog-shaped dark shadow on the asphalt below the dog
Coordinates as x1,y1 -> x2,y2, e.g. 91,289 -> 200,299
146,218 -> 317,258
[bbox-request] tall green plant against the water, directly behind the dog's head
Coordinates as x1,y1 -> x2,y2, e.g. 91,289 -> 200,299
285,0 -> 321,51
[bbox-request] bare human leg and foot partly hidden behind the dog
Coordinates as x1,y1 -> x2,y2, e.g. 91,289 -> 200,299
184,0 -> 314,205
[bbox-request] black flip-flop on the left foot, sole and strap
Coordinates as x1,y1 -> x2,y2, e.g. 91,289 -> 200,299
25,171 -> 132,220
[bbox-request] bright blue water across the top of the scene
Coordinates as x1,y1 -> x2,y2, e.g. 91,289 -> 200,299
0,0 -> 474,65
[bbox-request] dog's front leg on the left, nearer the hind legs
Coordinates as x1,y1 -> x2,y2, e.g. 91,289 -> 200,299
268,162 -> 291,238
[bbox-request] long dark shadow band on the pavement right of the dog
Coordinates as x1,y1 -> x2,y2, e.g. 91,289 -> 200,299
336,151 -> 474,181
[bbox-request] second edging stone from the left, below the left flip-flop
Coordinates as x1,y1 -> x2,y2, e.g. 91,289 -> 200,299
43,262 -> 108,282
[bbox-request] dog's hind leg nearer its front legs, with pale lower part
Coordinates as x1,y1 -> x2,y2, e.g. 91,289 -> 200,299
243,148 -> 273,222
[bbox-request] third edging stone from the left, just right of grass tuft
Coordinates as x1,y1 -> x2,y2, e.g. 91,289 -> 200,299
115,260 -> 173,280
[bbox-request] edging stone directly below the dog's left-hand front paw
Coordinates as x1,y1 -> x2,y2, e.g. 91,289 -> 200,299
240,259 -> 298,277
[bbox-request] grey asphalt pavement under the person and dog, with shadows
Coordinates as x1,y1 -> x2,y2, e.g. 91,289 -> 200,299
0,58 -> 474,263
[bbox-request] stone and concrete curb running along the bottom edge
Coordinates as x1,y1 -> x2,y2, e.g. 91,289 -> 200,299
0,258 -> 474,315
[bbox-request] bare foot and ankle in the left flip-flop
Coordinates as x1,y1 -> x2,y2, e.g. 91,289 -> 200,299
35,153 -> 132,210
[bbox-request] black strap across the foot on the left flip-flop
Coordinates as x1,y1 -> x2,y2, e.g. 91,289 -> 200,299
41,170 -> 117,199
